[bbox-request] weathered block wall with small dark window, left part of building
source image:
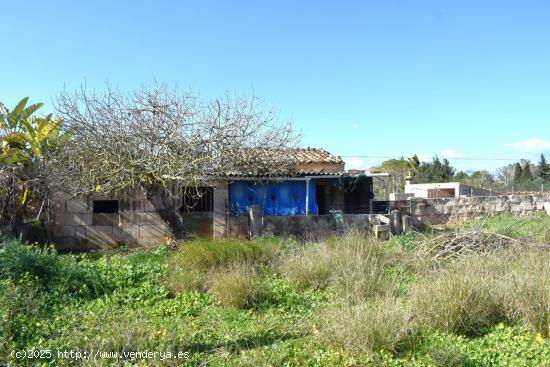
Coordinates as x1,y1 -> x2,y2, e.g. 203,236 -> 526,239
48,190 -> 216,251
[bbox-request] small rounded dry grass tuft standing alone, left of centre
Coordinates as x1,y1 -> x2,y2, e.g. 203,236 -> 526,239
208,263 -> 266,308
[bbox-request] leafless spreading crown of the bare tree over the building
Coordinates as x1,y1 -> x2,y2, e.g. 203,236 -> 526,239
51,85 -> 299,195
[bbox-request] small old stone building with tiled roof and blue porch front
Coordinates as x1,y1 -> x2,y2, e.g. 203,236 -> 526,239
48,148 -> 388,251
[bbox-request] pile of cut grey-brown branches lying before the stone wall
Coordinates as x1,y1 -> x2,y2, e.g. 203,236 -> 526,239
417,227 -> 550,260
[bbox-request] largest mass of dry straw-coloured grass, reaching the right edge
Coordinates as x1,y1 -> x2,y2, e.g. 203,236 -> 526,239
411,249 -> 550,335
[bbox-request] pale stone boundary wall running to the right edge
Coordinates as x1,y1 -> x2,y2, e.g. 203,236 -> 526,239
409,194 -> 550,226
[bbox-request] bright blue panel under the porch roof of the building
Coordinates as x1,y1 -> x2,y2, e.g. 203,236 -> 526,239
229,180 -> 317,215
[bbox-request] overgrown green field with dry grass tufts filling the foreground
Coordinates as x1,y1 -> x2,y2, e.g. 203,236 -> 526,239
0,216 -> 550,366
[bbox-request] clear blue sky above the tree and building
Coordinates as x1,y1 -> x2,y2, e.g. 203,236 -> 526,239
0,0 -> 550,169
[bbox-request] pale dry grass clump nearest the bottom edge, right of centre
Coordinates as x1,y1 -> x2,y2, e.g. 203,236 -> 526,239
319,297 -> 412,353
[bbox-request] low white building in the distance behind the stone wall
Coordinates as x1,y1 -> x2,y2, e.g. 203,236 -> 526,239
405,182 -> 498,199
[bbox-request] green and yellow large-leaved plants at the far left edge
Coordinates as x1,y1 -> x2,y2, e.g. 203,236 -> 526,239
0,97 -> 70,230
